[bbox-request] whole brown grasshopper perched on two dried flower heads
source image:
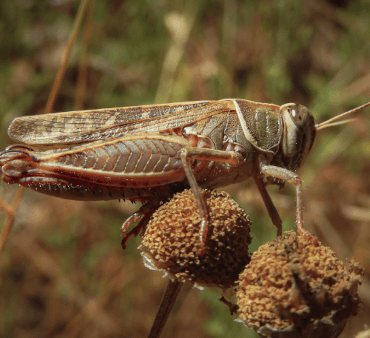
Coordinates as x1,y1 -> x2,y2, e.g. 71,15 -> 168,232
0,99 -> 370,248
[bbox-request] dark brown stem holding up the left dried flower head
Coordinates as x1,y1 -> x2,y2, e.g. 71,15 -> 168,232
148,280 -> 183,338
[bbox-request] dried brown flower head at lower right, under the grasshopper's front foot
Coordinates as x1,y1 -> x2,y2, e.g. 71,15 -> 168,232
237,231 -> 363,338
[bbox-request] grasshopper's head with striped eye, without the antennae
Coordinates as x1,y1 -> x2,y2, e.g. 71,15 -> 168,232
280,103 -> 316,171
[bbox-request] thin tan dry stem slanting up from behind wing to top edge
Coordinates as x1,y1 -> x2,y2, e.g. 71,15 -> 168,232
44,0 -> 89,114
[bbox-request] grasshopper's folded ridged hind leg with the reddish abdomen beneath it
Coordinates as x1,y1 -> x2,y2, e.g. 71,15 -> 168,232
0,135 -> 189,200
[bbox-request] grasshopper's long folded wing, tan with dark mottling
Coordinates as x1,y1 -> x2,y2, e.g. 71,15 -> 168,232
8,101 -> 233,146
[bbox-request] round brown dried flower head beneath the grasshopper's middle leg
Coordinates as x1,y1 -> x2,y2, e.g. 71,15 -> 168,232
140,189 -> 251,288
